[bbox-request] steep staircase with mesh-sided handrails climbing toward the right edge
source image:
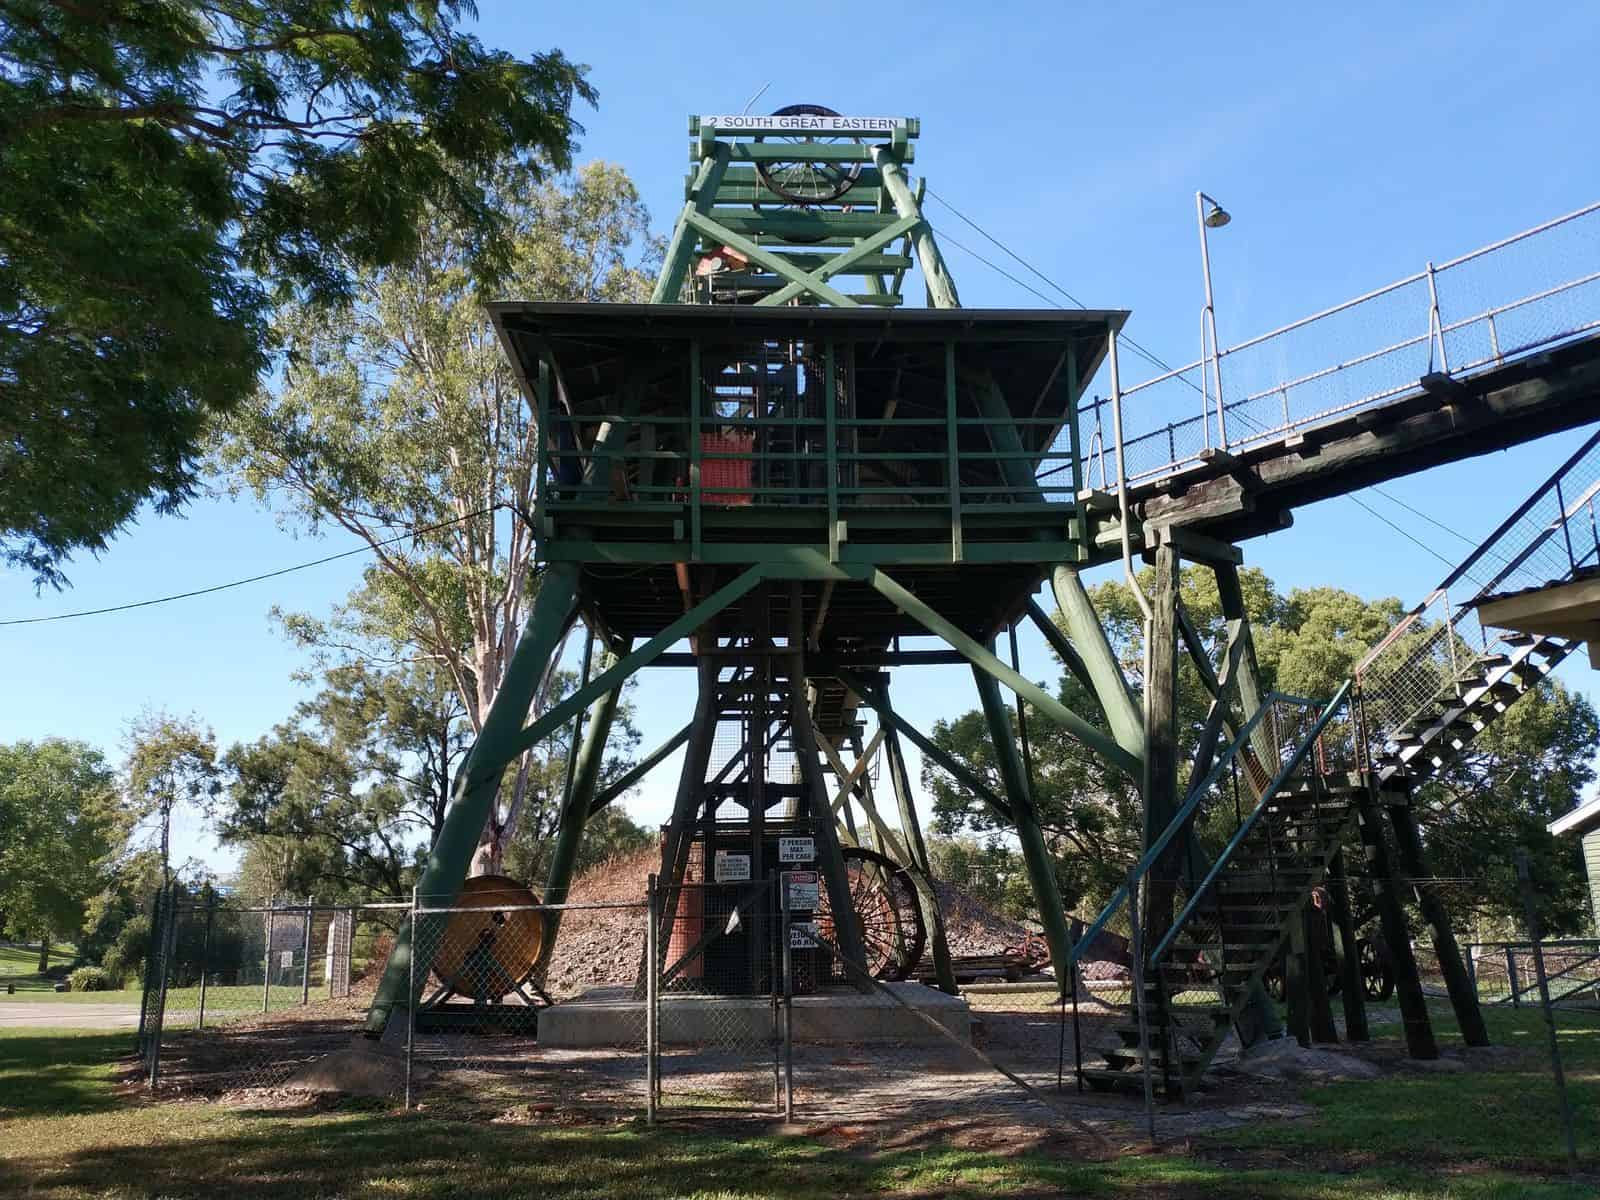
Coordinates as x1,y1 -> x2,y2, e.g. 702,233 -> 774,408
1074,434 -> 1600,1098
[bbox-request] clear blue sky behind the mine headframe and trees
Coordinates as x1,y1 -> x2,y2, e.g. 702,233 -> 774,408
0,0 -> 1600,876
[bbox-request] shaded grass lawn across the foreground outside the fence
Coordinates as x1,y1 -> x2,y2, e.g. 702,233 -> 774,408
0,1013 -> 1600,1200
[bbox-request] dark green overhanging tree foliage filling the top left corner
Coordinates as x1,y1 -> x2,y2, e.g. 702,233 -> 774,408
0,0 -> 594,586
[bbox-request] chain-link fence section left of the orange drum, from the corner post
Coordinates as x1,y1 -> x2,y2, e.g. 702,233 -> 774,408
141,894 -> 406,1096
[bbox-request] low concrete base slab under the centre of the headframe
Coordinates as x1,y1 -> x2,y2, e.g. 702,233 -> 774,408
539,982 -> 973,1048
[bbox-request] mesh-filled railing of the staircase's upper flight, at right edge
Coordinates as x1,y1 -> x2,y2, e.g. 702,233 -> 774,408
1355,432 -> 1600,750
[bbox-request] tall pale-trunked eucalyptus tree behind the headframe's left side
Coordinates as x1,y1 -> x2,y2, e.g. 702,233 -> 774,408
219,163 -> 659,872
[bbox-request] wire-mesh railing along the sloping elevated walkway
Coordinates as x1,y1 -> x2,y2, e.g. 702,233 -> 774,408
1080,203 -> 1600,488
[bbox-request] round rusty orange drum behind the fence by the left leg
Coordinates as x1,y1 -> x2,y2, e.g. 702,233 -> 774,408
421,875 -> 544,1003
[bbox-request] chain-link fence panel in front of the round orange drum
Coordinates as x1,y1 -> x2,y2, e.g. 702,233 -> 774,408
408,886 -> 650,1122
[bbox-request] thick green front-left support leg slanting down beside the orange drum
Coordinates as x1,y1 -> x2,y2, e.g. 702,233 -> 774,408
366,563 -> 578,1037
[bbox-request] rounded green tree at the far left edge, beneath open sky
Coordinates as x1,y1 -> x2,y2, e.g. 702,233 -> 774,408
0,738 -> 126,941
